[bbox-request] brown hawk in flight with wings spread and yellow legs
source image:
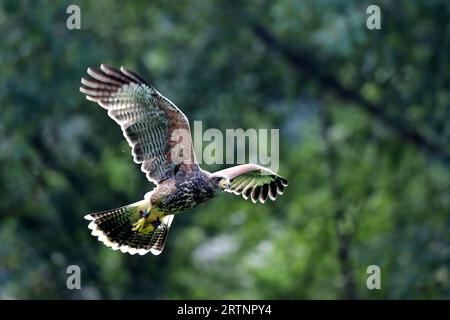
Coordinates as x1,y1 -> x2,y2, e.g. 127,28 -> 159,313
80,64 -> 287,255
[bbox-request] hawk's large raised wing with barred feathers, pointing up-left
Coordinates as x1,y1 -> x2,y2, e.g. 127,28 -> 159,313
80,64 -> 198,183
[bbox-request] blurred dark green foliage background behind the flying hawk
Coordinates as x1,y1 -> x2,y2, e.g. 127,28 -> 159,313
0,0 -> 450,299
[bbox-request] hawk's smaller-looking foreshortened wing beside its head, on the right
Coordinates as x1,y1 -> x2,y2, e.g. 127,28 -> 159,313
214,164 -> 288,203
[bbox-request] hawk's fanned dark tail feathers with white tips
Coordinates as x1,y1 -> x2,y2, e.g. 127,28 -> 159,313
84,200 -> 173,255
